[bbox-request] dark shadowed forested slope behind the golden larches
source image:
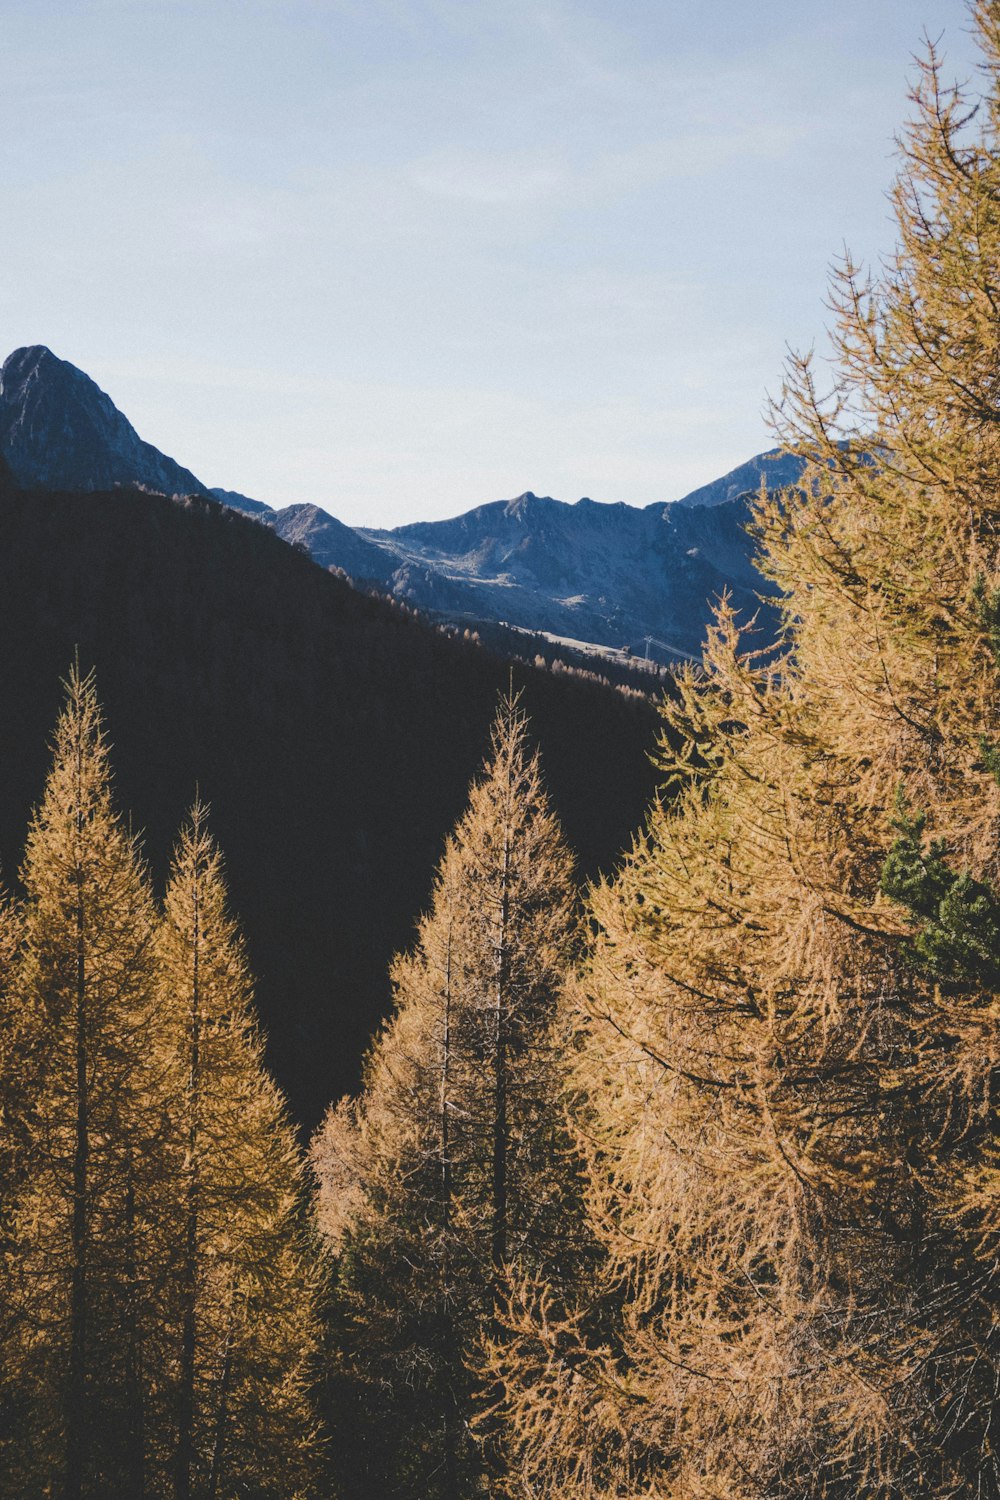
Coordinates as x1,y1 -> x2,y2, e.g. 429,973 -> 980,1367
0,465 -> 657,1127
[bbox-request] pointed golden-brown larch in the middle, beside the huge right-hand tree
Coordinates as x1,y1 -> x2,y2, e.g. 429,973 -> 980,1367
313,699 -> 585,1500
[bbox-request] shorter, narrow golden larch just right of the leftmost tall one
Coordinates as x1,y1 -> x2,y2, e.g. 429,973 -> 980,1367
157,804 -> 321,1500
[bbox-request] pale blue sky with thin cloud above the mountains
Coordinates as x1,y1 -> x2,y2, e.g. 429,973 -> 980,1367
0,0 -> 976,527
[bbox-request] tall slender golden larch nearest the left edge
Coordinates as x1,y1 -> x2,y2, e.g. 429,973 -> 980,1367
0,671 -> 169,1500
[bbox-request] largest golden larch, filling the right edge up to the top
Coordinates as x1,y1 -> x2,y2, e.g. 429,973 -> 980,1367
495,0 -> 1000,1500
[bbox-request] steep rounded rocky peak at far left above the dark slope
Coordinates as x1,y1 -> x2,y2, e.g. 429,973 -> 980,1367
0,344 -> 205,495
